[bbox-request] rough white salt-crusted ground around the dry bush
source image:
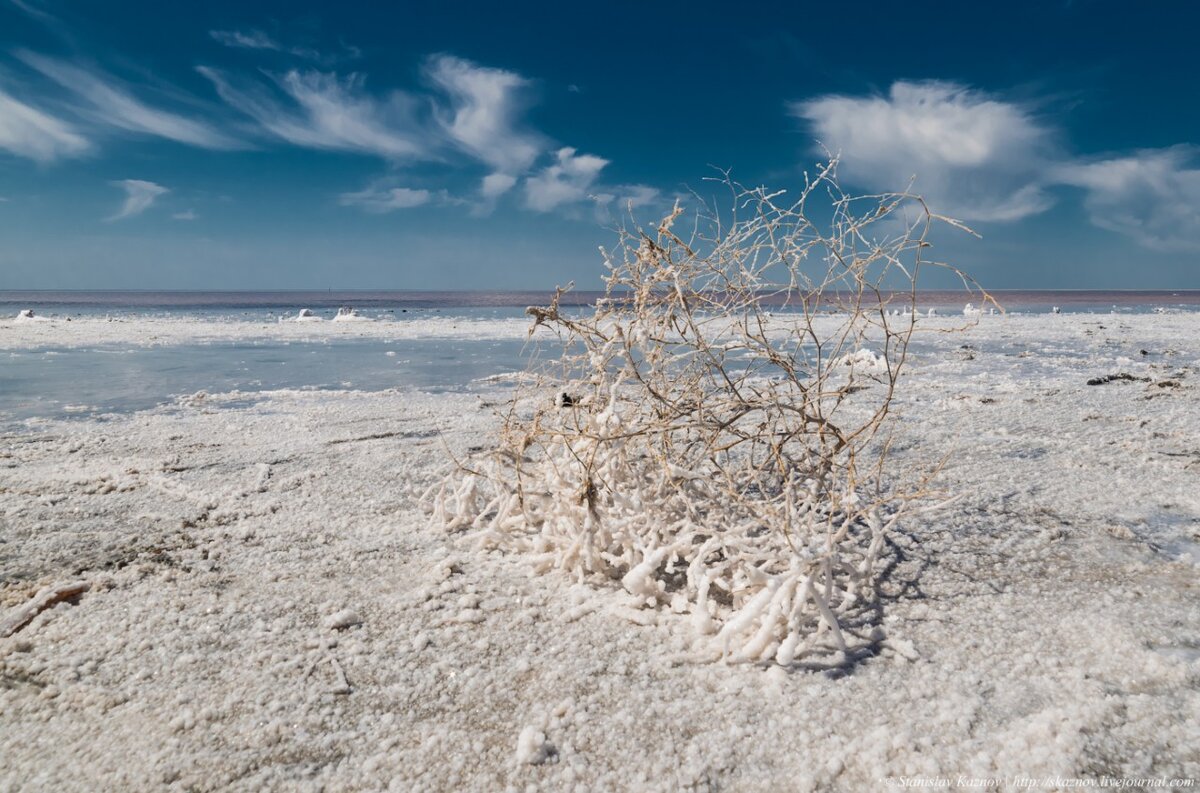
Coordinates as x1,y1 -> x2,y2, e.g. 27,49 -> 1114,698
0,314 -> 1200,791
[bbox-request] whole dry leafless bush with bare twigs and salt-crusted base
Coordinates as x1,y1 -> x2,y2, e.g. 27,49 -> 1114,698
430,161 -> 988,665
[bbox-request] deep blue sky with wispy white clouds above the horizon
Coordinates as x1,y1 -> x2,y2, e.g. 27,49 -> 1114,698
0,0 -> 1200,289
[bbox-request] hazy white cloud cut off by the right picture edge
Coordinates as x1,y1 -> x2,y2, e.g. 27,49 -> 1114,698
1055,146 -> 1200,251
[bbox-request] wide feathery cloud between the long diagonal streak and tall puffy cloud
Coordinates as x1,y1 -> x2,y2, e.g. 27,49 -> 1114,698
198,66 -> 430,160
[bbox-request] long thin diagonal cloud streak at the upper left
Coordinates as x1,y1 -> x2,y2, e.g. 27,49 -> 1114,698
18,52 -> 241,149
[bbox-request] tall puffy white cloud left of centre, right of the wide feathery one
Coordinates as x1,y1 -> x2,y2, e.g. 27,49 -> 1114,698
426,55 -> 544,177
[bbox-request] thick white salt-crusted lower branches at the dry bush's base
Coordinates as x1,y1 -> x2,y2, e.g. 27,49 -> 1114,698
426,431 -> 901,666
